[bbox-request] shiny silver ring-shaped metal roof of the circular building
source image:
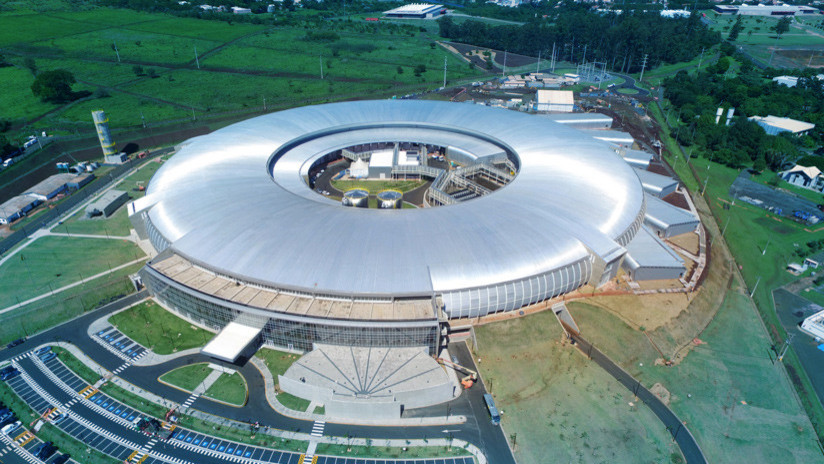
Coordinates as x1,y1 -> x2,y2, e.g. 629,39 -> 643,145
141,100 -> 644,316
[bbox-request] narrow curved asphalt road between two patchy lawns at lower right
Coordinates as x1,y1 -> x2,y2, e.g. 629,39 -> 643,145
572,335 -> 707,464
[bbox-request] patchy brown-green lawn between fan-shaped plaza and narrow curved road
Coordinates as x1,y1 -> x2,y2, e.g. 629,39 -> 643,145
475,311 -> 680,464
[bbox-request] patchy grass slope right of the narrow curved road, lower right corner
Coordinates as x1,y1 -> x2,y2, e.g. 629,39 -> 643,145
570,285 -> 821,463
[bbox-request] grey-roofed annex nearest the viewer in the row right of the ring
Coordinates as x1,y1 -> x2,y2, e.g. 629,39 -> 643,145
623,226 -> 687,281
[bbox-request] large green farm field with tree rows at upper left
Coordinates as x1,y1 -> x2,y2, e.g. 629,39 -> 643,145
0,4 -> 490,136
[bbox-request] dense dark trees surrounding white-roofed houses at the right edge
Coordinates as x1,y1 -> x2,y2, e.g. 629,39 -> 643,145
664,43 -> 824,170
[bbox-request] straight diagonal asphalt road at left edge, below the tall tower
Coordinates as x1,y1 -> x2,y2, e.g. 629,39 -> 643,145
0,148 -> 173,256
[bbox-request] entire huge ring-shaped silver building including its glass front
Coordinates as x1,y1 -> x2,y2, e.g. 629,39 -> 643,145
130,100 -> 645,356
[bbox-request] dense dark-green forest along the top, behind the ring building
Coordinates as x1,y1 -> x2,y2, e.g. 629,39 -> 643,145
438,4 -> 721,72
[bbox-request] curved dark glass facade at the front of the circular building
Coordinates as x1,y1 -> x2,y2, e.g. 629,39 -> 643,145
141,268 -> 440,354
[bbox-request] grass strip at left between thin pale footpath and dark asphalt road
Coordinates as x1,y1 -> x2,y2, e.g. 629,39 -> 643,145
0,263 -> 143,343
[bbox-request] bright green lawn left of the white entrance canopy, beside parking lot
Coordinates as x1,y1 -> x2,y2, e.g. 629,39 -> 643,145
109,300 -> 214,354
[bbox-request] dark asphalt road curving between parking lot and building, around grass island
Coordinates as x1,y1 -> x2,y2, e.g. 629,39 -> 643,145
0,290 -> 515,464
